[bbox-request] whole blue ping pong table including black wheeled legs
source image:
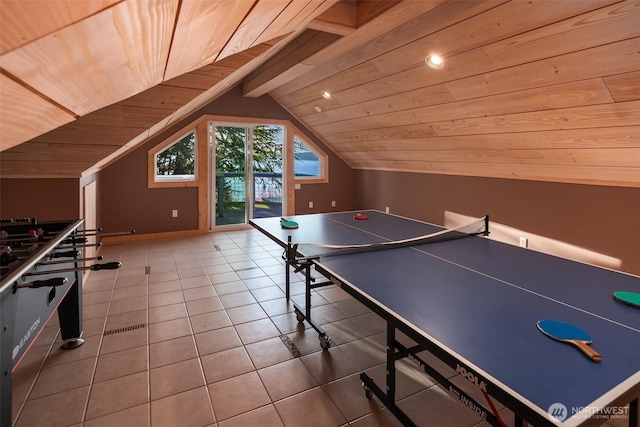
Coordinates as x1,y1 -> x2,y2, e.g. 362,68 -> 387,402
251,210 -> 640,427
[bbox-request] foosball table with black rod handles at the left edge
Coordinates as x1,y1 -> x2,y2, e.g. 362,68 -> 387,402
0,218 -> 120,427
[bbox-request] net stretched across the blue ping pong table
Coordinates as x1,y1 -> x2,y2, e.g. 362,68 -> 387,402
293,215 -> 489,258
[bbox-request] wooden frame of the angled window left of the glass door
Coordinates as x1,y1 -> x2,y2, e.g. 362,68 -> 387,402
147,126 -> 199,188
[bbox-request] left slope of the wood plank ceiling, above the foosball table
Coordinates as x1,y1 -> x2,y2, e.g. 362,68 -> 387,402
0,0 -> 344,177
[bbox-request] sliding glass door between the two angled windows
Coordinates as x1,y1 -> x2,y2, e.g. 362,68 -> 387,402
211,124 -> 284,227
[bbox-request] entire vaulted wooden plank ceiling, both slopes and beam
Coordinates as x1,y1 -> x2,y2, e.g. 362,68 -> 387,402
0,0 -> 640,187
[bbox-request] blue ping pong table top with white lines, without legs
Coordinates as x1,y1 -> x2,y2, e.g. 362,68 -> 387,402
252,211 -> 640,425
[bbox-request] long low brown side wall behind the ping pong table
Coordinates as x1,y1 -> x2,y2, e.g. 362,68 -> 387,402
354,170 -> 640,275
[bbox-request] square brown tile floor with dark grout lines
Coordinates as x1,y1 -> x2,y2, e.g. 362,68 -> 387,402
8,229 -> 624,427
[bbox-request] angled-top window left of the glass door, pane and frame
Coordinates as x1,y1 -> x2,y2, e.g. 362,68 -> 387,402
149,129 -> 197,186
